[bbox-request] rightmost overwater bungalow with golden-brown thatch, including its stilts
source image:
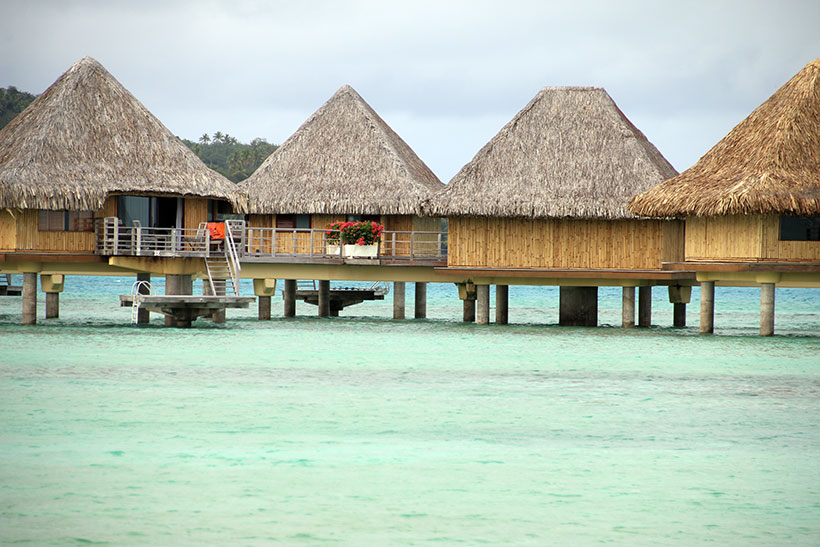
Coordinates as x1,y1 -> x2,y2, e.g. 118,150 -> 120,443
629,59 -> 820,335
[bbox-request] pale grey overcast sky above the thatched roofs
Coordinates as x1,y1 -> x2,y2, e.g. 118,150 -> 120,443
0,0 -> 820,182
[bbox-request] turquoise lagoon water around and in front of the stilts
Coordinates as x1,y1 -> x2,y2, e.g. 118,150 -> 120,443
0,277 -> 820,545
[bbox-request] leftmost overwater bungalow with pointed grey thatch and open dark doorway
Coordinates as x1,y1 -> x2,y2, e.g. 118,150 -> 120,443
0,57 -> 246,323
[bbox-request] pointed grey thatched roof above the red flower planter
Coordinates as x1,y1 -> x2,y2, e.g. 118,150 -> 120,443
241,86 -> 444,214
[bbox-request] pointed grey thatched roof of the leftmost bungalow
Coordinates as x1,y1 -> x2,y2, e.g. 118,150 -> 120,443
0,57 -> 245,212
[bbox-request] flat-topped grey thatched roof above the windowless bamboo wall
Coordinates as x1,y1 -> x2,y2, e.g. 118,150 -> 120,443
425,87 -> 677,219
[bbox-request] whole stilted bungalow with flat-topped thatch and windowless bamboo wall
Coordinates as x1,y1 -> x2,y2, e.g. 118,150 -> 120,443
425,87 -> 688,326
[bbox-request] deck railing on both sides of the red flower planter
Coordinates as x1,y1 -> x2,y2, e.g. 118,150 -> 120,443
245,228 -> 447,260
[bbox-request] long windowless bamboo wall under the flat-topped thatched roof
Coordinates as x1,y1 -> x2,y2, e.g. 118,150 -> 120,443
448,217 -> 683,270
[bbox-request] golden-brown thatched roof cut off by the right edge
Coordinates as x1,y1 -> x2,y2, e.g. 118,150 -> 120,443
629,59 -> 820,217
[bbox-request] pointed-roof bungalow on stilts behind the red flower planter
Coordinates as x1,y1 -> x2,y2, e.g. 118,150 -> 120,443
241,85 -> 446,317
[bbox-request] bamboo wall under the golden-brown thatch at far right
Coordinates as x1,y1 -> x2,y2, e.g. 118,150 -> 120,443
686,215 -> 820,262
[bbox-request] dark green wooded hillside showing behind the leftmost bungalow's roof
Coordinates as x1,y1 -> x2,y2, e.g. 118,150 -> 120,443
0,86 -> 279,182
